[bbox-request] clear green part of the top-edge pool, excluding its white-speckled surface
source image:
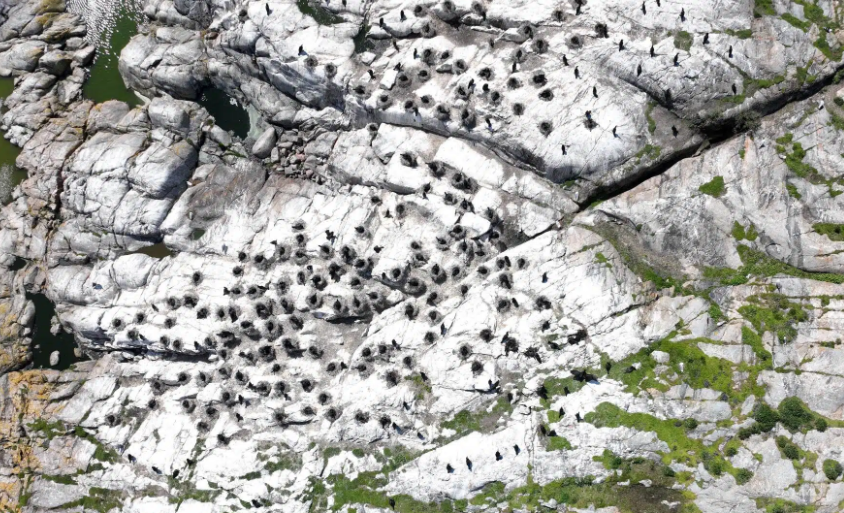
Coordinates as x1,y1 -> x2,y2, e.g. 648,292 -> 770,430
82,2 -> 142,107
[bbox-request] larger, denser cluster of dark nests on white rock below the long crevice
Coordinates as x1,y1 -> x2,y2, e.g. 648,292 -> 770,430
107,155 -> 586,456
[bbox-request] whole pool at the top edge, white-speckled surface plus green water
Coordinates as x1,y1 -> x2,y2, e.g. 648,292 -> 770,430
68,0 -> 144,107
